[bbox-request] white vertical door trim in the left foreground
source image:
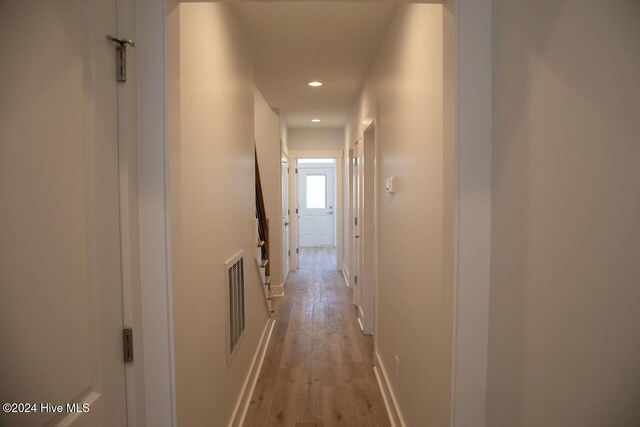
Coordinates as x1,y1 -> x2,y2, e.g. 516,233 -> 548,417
137,0 -> 180,427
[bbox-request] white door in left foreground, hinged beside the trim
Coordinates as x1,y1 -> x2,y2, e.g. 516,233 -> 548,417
0,0 -> 127,426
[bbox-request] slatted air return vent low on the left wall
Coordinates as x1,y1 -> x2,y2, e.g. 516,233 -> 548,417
225,251 -> 245,363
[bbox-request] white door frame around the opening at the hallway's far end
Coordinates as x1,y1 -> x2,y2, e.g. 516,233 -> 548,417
289,150 -> 344,271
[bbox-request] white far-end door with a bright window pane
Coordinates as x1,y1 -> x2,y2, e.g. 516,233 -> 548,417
298,166 -> 335,246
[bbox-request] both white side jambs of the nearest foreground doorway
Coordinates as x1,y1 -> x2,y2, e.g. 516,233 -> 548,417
139,0 -> 493,427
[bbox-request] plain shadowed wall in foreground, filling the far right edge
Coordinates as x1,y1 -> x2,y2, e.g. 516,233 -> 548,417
487,0 -> 640,427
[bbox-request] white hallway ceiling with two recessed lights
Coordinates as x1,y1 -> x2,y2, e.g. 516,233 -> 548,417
233,2 -> 396,127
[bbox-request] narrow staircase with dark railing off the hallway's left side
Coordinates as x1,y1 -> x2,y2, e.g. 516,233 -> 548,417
255,151 -> 273,313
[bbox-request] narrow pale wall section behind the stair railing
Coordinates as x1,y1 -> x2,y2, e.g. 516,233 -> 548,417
254,88 -> 284,294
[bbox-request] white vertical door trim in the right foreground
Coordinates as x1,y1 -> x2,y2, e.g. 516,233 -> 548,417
443,0 -> 493,427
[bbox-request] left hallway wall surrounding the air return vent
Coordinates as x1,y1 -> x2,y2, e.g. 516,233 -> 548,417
168,3 -> 268,426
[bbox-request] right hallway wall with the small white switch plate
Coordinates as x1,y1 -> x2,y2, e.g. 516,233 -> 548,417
343,4 -> 453,426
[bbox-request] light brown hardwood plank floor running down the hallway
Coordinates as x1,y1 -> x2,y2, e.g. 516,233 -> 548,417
244,248 -> 390,427
